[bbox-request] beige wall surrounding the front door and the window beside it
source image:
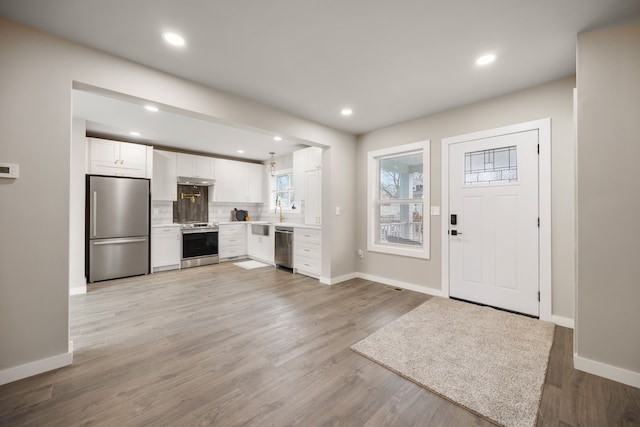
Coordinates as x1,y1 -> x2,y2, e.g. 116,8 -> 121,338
357,78 -> 575,325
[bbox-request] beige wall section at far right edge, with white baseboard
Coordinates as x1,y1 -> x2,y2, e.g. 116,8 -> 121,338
574,25 -> 640,387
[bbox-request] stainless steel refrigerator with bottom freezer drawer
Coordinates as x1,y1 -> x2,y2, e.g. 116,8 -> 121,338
85,175 -> 150,283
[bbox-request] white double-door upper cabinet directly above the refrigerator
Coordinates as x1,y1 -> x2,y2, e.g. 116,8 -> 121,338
89,138 -> 153,178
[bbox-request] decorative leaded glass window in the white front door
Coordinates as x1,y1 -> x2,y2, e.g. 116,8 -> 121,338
464,145 -> 518,185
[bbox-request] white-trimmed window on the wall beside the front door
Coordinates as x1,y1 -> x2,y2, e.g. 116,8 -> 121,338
367,141 -> 430,259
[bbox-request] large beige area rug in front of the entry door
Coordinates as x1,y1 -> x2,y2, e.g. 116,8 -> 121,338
351,297 -> 555,427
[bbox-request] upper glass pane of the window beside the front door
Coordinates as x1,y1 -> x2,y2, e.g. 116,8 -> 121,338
379,153 -> 423,200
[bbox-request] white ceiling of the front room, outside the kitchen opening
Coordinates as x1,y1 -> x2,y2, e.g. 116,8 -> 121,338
0,0 -> 640,139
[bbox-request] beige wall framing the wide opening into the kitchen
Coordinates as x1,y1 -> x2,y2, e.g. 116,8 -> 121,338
0,18 -> 355,381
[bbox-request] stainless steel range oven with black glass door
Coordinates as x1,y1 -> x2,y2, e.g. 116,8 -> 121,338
180,223 -> 220,268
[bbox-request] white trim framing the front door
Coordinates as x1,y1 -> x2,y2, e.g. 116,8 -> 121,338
440,118 -> 552,322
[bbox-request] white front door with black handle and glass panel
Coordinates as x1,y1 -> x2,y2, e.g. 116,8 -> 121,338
445,129 -> 540,316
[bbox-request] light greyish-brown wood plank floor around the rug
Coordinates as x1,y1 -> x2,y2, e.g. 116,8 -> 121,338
0,263 -> 640,426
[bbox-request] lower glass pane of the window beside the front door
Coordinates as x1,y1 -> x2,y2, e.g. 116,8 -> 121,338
379,203 -> 423,246
